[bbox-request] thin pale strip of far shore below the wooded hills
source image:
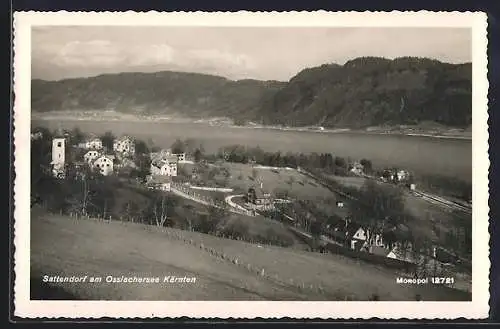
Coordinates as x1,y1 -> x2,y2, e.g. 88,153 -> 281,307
31,112 -> 472,140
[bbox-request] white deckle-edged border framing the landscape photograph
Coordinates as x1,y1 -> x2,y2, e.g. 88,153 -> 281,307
14,11 -> 490,319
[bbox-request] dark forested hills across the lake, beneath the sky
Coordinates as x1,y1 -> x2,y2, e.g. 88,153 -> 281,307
32,57 -> 472,128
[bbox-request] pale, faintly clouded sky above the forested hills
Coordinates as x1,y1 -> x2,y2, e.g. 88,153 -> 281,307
31,26 -> 472,81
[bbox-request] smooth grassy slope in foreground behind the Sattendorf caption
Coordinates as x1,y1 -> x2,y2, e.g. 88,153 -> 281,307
31,214 -> 471,301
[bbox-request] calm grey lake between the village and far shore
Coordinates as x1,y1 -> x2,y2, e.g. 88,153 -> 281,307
32,120 -> 472,182
